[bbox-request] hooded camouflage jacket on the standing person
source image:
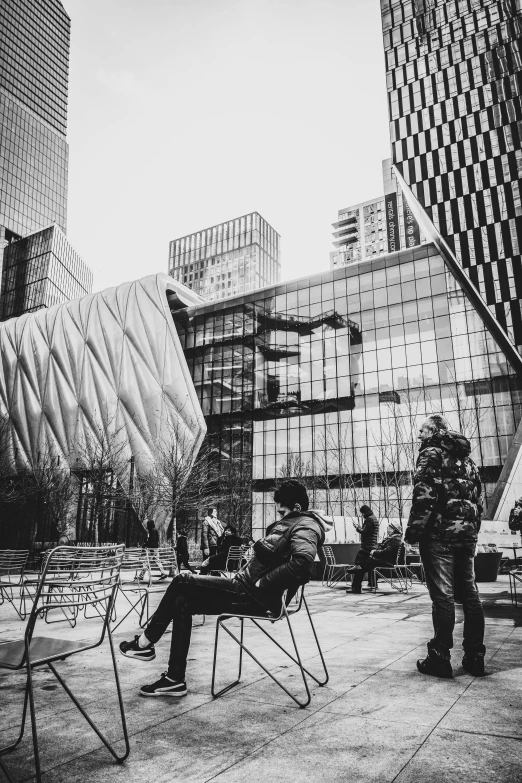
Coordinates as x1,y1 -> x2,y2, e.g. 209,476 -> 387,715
405,431 -> 482,544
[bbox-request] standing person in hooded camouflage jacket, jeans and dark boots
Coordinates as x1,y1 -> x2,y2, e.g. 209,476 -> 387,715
405,414 -> 486,677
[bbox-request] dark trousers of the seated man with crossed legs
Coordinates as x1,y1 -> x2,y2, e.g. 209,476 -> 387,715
141,574 -> 265,681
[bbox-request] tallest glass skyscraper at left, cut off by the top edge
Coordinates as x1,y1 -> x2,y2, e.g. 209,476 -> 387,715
0,0 -> 70,239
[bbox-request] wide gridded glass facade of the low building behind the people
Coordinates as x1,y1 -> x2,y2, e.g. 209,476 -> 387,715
173,244 -> 522,536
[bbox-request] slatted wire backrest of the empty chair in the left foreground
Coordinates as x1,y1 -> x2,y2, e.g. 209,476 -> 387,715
26,544 -> 125,642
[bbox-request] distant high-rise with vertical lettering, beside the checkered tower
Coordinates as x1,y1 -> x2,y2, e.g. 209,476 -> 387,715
330,158 -> 426,269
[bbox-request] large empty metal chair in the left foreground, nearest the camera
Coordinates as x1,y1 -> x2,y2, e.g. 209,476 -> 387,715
0,545 -> 130,783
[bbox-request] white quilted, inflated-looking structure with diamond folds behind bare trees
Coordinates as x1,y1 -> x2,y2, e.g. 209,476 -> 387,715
0,274 -> 206,516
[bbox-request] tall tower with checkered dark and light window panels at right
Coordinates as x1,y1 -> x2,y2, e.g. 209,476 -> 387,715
381,0 -> 522,350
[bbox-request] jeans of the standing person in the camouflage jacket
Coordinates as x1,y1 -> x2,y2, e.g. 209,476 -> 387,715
420,541 -> 486,656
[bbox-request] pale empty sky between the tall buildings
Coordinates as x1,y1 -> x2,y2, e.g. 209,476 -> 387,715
62,0 -> 390,291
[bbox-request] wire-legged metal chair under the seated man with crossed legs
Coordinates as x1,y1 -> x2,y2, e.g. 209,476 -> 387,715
211,586 -> 329,708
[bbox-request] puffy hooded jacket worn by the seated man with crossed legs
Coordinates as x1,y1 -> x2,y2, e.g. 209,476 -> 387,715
236,510 -> 332,611
